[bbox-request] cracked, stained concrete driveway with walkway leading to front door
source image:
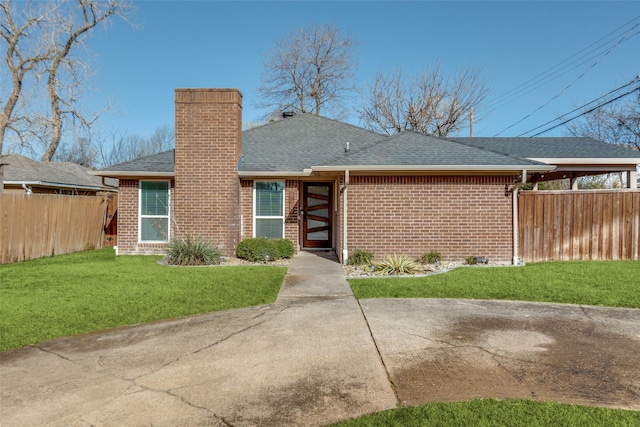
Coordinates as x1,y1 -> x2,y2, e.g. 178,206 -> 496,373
0,252 -> 640,426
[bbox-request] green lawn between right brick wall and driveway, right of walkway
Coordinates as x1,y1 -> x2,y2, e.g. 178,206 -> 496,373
349,261 -> 640,308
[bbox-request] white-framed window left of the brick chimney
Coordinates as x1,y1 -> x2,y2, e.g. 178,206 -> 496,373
139,181 -> 170,242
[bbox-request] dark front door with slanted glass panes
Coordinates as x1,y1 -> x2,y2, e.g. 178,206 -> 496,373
302,182 -> 333,249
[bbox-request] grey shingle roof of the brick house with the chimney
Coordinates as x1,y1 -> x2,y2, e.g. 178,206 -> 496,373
93,114 -> 640,177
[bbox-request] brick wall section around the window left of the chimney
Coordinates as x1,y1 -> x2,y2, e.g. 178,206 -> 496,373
118,179 -> 174,255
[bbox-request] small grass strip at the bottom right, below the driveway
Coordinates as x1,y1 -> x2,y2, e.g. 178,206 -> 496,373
334,399 -> 640,427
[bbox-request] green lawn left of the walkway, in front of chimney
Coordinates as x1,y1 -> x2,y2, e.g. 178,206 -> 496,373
0,248 -> 286,351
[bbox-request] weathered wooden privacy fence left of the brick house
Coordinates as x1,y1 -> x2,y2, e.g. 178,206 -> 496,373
0,194 -> 107,264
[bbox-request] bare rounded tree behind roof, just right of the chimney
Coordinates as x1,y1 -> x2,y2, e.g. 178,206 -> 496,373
258,24 -> 356,117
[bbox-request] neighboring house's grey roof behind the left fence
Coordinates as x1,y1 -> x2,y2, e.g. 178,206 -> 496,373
0,154 -> 118,191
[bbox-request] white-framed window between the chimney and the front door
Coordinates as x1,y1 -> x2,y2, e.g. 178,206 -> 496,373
253,181 -> 284,238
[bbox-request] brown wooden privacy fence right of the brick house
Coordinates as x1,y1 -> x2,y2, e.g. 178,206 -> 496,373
518,190 -> 640,262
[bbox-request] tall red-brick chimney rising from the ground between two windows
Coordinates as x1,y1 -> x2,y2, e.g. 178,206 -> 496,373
173,89 -> 242,255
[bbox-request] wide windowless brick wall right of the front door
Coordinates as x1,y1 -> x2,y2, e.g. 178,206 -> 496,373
340,176 -> 515,262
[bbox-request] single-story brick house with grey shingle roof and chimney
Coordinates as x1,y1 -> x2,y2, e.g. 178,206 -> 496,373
94,89 -> 640,263
